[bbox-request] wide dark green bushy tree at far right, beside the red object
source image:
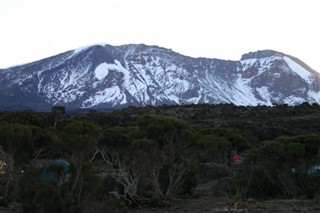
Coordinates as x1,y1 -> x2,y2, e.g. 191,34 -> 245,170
235,135 -> 320,198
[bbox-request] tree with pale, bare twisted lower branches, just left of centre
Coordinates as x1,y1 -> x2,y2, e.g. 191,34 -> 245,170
96,126 -> 142,204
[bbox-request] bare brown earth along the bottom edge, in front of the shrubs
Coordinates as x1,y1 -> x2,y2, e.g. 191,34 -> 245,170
129,182 -> 320,213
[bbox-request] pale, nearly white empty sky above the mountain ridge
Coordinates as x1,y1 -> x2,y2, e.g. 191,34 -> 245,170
0,0 -> 320,72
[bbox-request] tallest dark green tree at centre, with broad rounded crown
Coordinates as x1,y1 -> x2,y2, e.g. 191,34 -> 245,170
137,115 -> 195,199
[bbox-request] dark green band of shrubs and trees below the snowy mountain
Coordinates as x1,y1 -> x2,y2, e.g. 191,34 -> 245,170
0,104 -> 320,212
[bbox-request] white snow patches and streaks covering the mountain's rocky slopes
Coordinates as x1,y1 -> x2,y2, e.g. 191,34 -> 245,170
25,46 -> 320,107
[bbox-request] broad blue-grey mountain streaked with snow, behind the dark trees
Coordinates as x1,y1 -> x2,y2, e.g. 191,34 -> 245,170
0,44 -> 320,111
